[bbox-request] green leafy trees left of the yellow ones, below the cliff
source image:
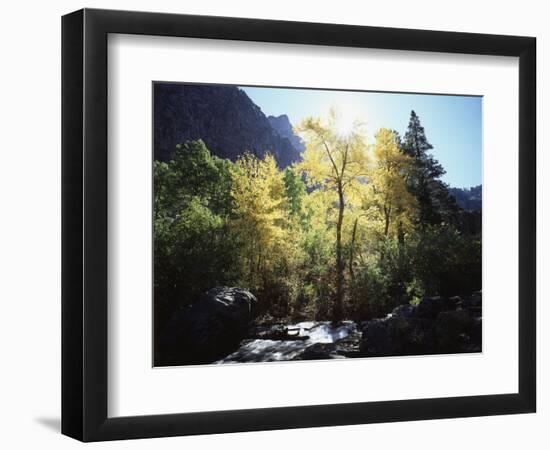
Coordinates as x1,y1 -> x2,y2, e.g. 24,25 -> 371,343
154,141 -> 243,331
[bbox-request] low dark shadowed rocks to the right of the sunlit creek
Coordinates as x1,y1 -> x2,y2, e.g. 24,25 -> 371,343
360,292 -> 481,356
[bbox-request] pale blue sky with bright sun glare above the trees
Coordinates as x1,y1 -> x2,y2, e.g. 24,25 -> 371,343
241,87 -> 482,187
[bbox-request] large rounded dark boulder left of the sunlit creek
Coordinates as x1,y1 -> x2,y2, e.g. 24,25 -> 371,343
155,287 -> 257,366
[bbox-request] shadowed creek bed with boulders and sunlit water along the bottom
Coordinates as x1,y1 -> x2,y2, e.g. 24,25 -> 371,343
155,287 -> 482,365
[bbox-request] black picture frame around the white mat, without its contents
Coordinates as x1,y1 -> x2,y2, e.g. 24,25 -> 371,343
62,9 -> 536,441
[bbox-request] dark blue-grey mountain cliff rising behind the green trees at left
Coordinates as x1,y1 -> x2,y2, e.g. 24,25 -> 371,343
154,83 -> 301,168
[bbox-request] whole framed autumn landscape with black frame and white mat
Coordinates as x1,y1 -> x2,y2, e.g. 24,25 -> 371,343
62,9 -> 536,441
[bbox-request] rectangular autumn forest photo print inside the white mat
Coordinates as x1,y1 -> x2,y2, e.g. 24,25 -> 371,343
152,81 -> 483,367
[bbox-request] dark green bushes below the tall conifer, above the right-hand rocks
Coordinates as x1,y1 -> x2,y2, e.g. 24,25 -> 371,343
350,226 -> 481,320
